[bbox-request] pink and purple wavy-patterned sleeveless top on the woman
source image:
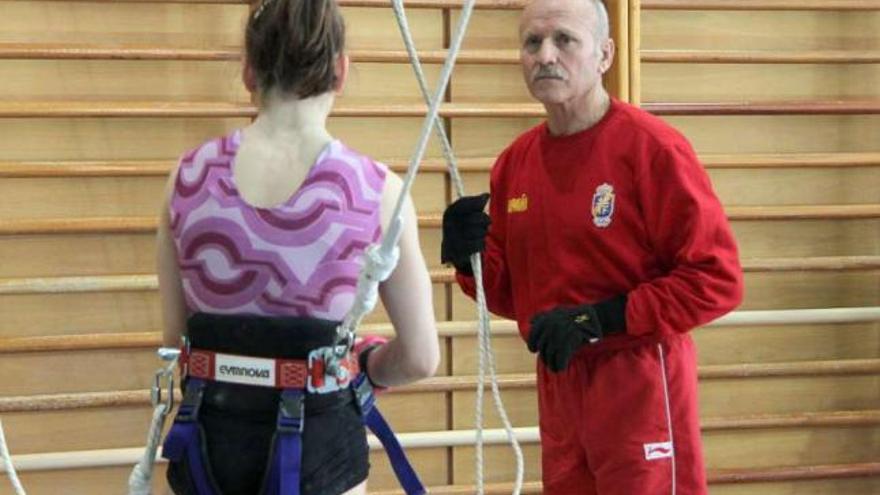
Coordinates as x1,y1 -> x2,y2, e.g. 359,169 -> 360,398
170,131 -> 387,320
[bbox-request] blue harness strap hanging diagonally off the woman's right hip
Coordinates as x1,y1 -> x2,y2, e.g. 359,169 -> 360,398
352,373 -> 427,495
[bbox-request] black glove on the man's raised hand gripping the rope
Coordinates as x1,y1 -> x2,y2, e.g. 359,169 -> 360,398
440,193 -> 491,275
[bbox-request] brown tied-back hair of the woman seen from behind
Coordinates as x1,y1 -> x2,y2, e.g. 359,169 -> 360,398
245,0 -> 345,98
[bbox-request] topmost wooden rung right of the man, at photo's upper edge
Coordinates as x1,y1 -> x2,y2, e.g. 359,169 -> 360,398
641,0 -> 880,10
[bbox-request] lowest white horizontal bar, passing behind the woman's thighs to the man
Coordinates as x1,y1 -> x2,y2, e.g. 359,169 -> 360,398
0,427 -> 540,473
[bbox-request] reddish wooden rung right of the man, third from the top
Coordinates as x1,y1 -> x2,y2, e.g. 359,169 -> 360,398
642,100 -> 880,116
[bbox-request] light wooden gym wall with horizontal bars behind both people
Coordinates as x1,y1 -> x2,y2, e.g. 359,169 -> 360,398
0,0 -> 880,494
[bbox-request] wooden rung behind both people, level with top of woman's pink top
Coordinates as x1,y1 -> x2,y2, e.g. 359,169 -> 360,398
0,152 -> 880,178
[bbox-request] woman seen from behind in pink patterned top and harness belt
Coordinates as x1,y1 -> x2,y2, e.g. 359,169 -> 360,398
158,0 -> 439,495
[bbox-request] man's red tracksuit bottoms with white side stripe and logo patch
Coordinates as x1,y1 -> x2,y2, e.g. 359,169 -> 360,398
538,334 -> 707,495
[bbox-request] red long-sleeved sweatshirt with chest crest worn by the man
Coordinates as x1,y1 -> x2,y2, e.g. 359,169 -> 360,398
457,100 -> 742,346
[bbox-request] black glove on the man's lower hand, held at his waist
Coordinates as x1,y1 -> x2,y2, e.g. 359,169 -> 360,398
528,295 -> 626,373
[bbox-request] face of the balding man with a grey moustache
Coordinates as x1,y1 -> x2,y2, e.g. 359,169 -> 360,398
520,0 -> 613,105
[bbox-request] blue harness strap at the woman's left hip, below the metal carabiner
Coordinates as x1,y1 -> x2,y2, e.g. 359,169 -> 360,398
162,378 -> 218,495
